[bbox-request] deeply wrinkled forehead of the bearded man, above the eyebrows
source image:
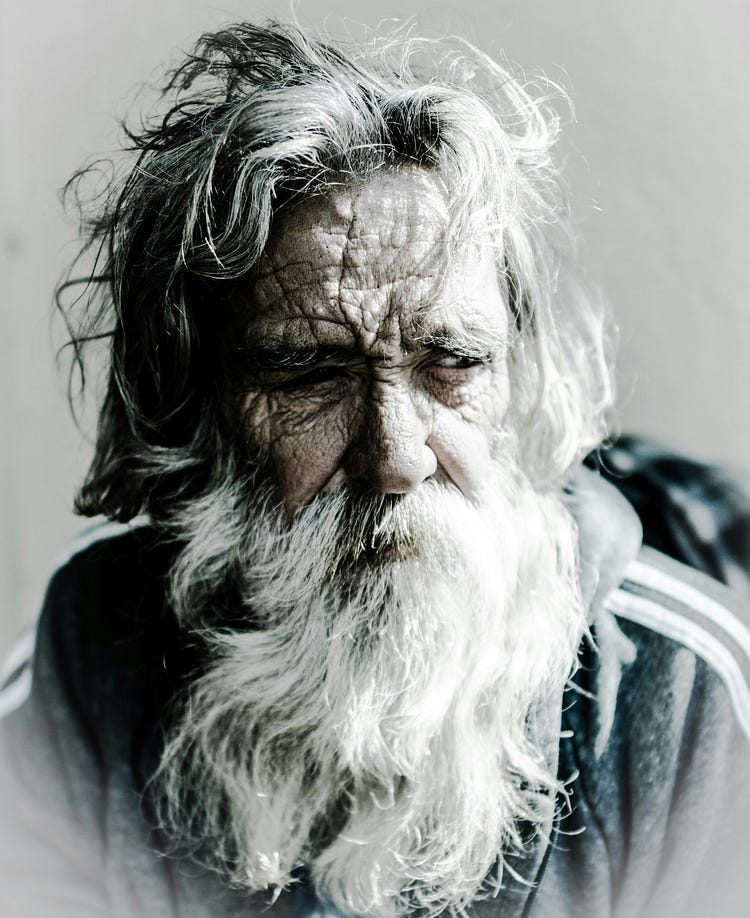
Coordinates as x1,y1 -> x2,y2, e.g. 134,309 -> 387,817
244,167 -> 508,354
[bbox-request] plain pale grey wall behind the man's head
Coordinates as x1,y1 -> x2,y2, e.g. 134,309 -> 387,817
0,0 -> 750,655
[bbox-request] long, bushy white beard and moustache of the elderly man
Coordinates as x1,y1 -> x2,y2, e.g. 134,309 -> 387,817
158,468 -> 585,918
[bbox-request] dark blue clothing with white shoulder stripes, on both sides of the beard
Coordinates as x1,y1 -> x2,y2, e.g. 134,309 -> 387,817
0,439 -> 750,918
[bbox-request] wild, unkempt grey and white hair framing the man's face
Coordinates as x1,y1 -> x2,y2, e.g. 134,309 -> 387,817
58,22 -> 610,520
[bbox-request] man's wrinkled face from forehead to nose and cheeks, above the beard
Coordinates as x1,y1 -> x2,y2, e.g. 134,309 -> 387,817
238,168 -> 509,513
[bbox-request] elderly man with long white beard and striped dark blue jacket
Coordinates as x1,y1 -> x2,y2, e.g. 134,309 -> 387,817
0,16 -> 750,918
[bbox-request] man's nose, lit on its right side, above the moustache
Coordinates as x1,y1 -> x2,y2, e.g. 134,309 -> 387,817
345,384 -> 437,494
